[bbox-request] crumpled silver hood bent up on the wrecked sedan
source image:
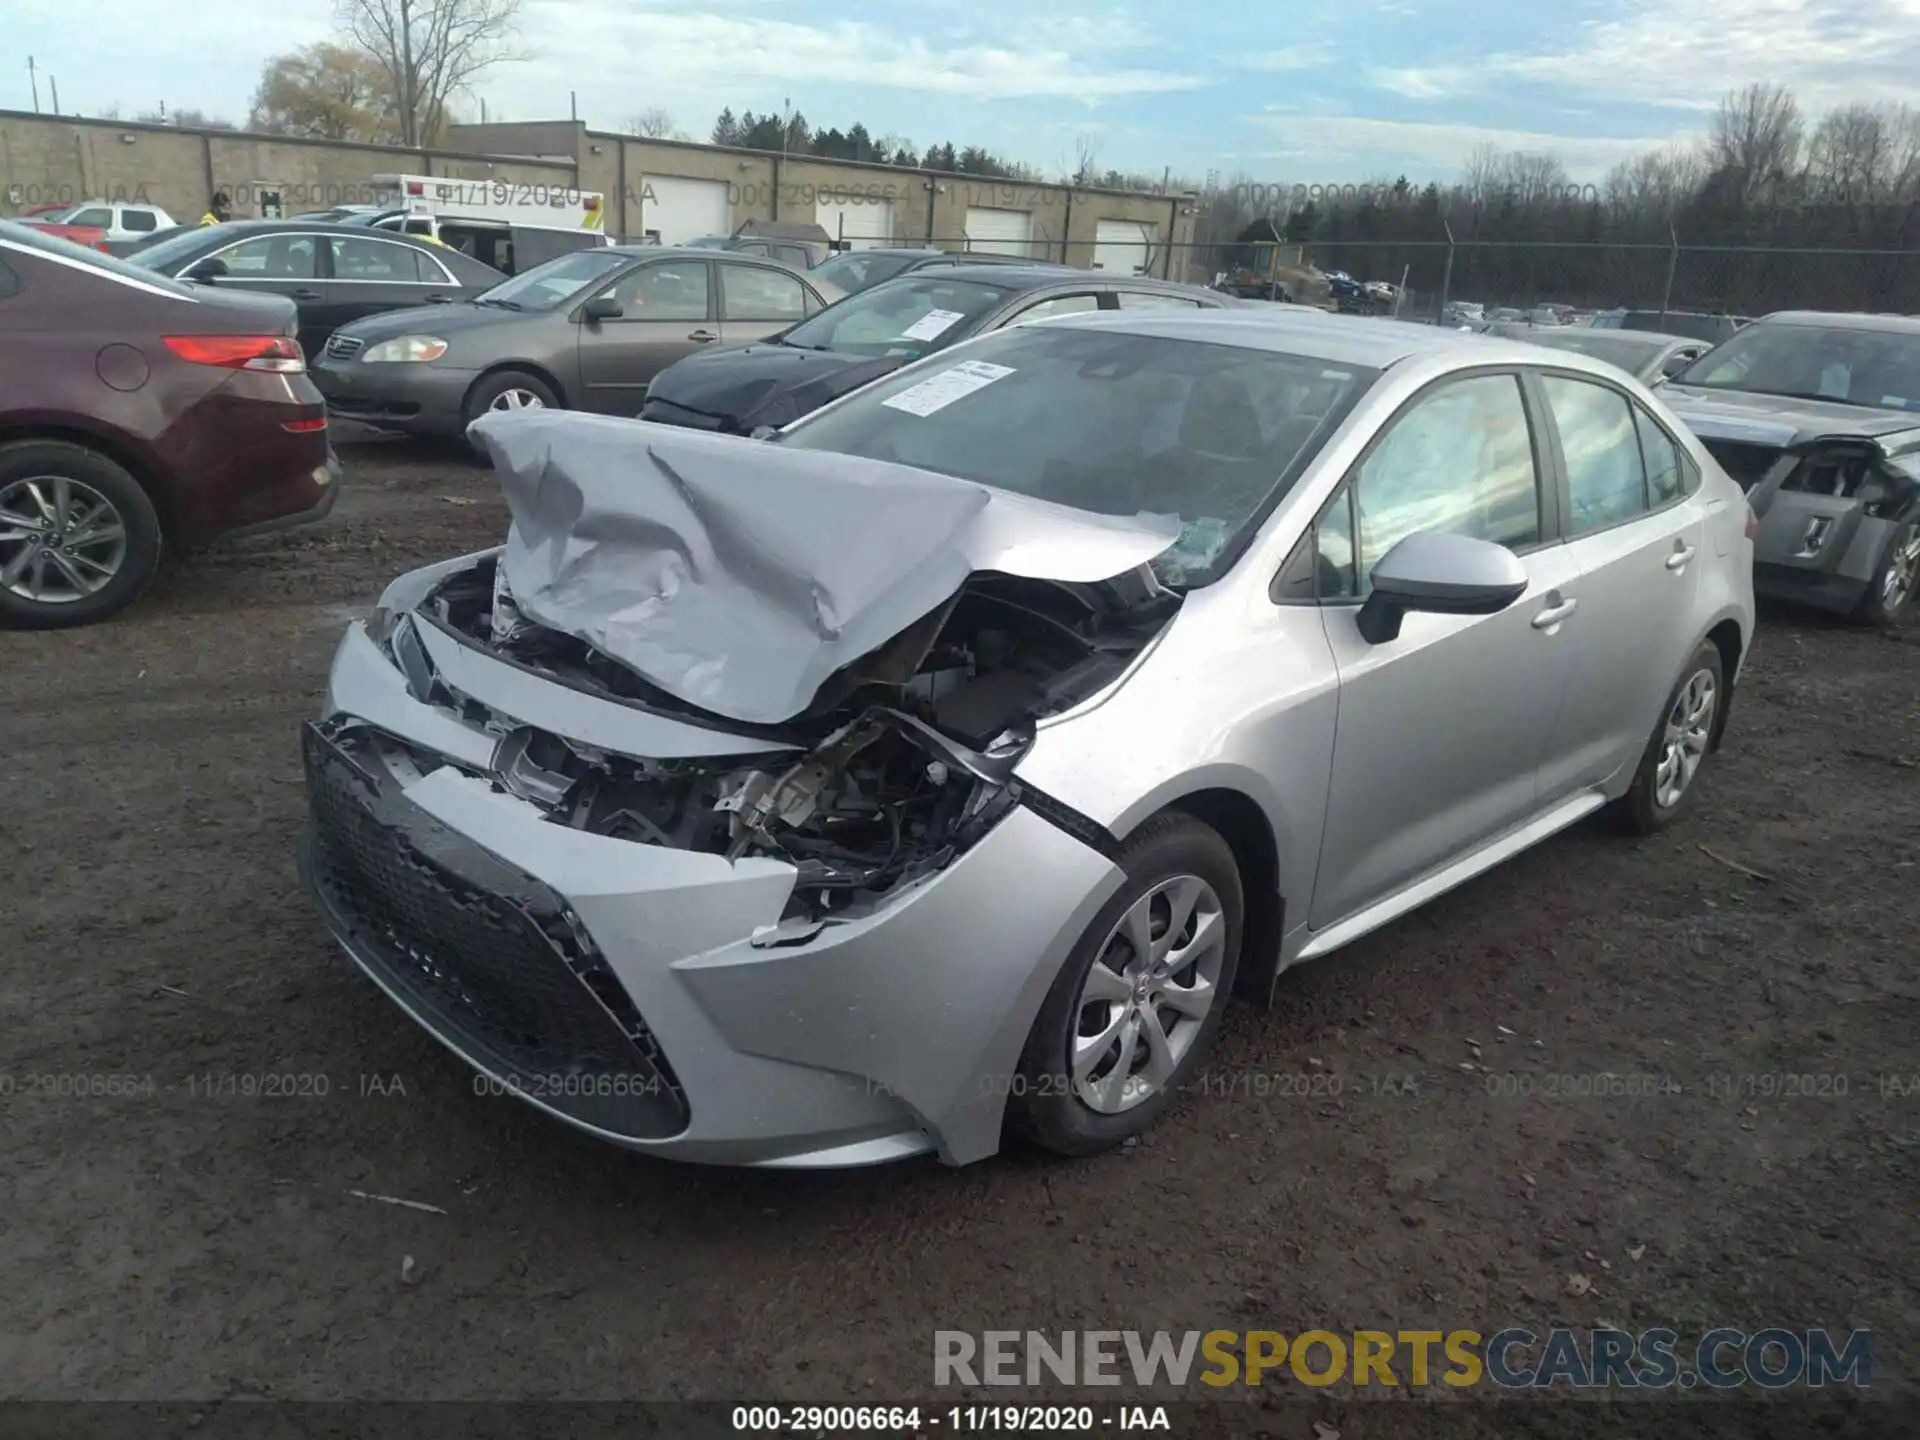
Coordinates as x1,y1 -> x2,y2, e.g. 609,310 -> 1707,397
468,411 -> 1181,724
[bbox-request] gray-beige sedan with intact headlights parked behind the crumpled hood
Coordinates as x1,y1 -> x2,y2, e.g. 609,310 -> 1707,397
309,246 -> 841,436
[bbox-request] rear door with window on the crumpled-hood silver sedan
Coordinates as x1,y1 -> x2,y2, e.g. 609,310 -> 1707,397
1528,371 -> 1707,803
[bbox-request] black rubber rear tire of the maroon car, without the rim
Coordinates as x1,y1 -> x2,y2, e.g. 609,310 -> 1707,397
0,440 -> 161,630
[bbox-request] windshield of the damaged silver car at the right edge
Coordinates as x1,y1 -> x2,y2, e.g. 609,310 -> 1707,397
1674,314 -> 1920,411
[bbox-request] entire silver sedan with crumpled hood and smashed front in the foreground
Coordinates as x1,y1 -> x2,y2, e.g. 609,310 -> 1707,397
301,311 -> 1753,1165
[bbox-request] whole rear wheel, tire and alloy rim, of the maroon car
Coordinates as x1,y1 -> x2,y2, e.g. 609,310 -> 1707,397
0,440 -> 161,630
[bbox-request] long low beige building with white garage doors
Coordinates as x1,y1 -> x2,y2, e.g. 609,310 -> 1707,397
0,111 -> 1194,278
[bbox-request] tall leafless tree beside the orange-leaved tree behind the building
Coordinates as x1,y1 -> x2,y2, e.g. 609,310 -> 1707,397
336,0 -> 520,146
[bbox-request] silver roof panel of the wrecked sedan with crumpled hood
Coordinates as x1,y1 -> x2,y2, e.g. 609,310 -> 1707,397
1046,305 -> 1590,371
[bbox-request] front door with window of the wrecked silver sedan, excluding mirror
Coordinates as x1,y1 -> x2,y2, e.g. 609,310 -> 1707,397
1309,371 -> 1578,929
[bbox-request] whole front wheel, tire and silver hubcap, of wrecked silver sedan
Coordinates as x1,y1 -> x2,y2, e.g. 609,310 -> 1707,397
1008,814 -> 1244,1156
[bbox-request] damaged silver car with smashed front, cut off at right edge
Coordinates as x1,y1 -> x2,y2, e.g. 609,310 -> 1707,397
1661,311 -> 1920,624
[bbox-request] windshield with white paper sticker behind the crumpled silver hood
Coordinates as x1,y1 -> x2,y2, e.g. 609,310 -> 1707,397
780,324 -> 1379,588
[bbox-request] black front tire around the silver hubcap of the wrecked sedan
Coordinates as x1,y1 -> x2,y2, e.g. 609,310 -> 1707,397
1006,812 -> 1246,1156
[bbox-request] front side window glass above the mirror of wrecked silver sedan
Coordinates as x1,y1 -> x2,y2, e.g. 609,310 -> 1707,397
1352,374 -> 1540,597
